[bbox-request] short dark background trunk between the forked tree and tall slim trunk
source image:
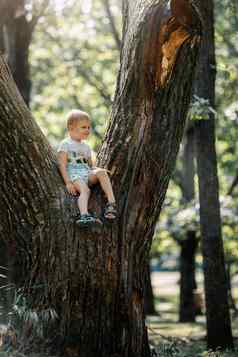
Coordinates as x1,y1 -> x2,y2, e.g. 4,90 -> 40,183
179,231 -> 198,322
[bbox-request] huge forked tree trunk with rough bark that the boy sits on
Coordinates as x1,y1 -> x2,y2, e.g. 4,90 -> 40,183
0,1 -> 200,357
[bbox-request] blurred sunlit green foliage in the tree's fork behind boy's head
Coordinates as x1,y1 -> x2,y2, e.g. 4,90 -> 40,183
31,0 -> 120,147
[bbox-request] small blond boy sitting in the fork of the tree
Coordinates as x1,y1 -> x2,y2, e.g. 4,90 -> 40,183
58,110 -> 117,225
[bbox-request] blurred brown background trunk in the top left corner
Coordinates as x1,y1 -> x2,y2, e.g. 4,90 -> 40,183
0,0 -> 50,106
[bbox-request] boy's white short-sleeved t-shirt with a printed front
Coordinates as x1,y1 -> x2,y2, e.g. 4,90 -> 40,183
57,138 -> 92,164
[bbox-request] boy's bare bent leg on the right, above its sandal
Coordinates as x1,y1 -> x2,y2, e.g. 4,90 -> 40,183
89,168 -> 115,203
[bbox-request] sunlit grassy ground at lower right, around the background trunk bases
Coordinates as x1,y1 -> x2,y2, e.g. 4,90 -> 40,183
146,294 -> 238,357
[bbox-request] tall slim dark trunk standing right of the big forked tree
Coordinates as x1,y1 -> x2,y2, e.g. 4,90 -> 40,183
195,0 -> 233,349
